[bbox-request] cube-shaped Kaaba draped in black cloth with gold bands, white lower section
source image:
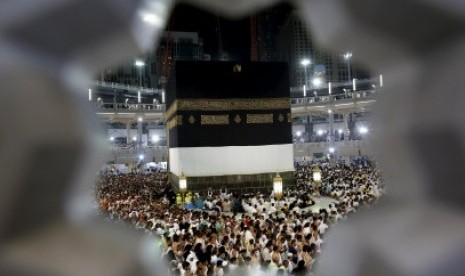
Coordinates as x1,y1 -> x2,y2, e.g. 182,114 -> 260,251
166,61 -> 294,192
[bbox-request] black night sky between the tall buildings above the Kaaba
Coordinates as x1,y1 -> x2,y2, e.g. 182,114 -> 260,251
167,5 -> 250,61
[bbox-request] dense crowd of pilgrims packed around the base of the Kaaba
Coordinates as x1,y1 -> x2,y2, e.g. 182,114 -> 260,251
97,161 -> 384,275
